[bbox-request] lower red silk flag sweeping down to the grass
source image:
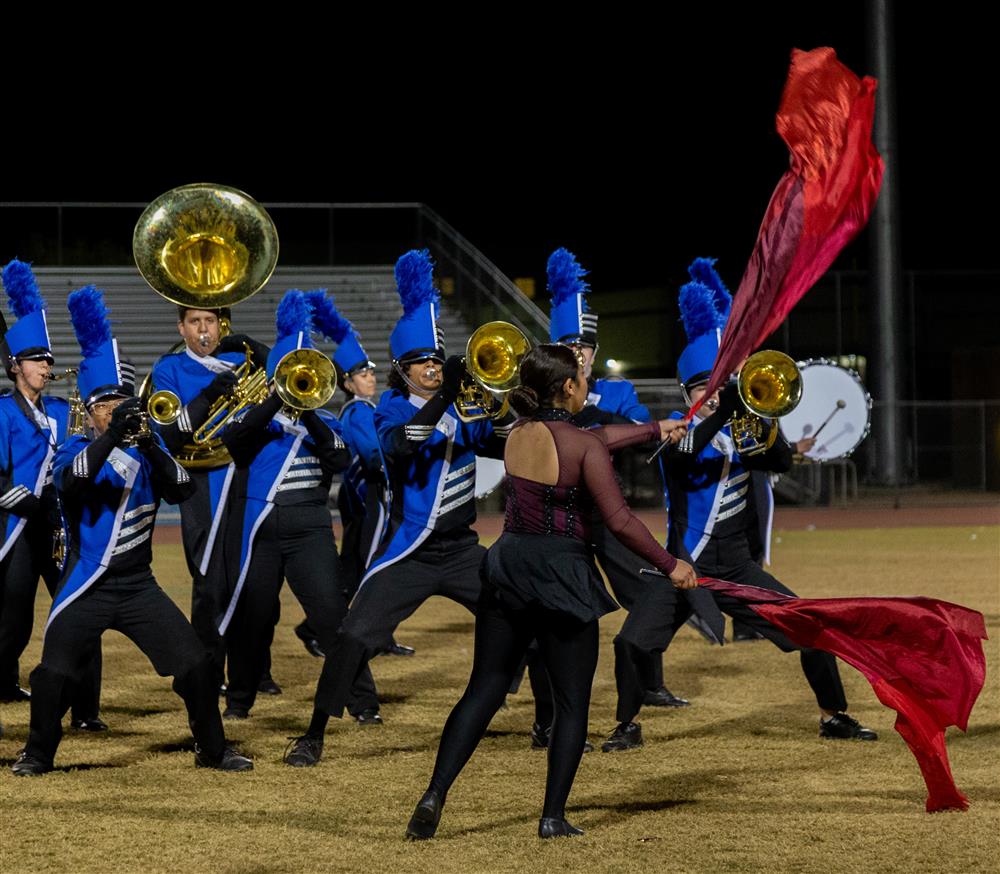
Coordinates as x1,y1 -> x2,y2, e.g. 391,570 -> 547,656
701,579 -> 987,812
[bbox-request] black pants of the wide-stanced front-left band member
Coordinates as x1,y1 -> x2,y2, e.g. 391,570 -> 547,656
26,568 -> 225,764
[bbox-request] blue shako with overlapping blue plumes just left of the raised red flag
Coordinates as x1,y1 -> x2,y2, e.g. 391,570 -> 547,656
677,258 -> 733,388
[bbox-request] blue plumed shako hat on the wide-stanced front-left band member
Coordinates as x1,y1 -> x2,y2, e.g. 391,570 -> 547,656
66,285 -> 135,408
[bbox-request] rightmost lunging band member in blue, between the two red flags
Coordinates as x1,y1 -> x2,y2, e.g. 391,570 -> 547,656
612,258 -> 878,749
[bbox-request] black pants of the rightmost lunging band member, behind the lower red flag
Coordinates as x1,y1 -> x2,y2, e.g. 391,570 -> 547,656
615,534 -> 847,721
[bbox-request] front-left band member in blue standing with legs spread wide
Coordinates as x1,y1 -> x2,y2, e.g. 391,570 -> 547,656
11,286 -> 253,776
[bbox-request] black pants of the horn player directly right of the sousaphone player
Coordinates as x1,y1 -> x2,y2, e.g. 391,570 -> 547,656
226,503 -> 378,714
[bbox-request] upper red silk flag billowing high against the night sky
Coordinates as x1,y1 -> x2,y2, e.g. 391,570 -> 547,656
686,48 -> 883,420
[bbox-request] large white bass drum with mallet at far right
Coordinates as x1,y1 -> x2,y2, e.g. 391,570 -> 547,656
779,359 -> 872,461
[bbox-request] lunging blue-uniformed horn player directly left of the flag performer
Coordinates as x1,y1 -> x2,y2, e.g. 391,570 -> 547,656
285,250 -> 509,767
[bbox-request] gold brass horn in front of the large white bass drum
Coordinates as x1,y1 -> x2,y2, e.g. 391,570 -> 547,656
729,349 -> 802,455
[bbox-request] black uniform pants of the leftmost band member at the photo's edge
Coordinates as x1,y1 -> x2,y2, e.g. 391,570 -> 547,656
0,521 -> 101,719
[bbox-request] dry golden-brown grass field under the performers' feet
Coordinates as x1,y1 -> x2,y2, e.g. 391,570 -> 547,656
0,526 -> 1000,874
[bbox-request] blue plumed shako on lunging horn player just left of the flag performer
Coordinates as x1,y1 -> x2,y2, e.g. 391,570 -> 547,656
389,249 -> 446,364
